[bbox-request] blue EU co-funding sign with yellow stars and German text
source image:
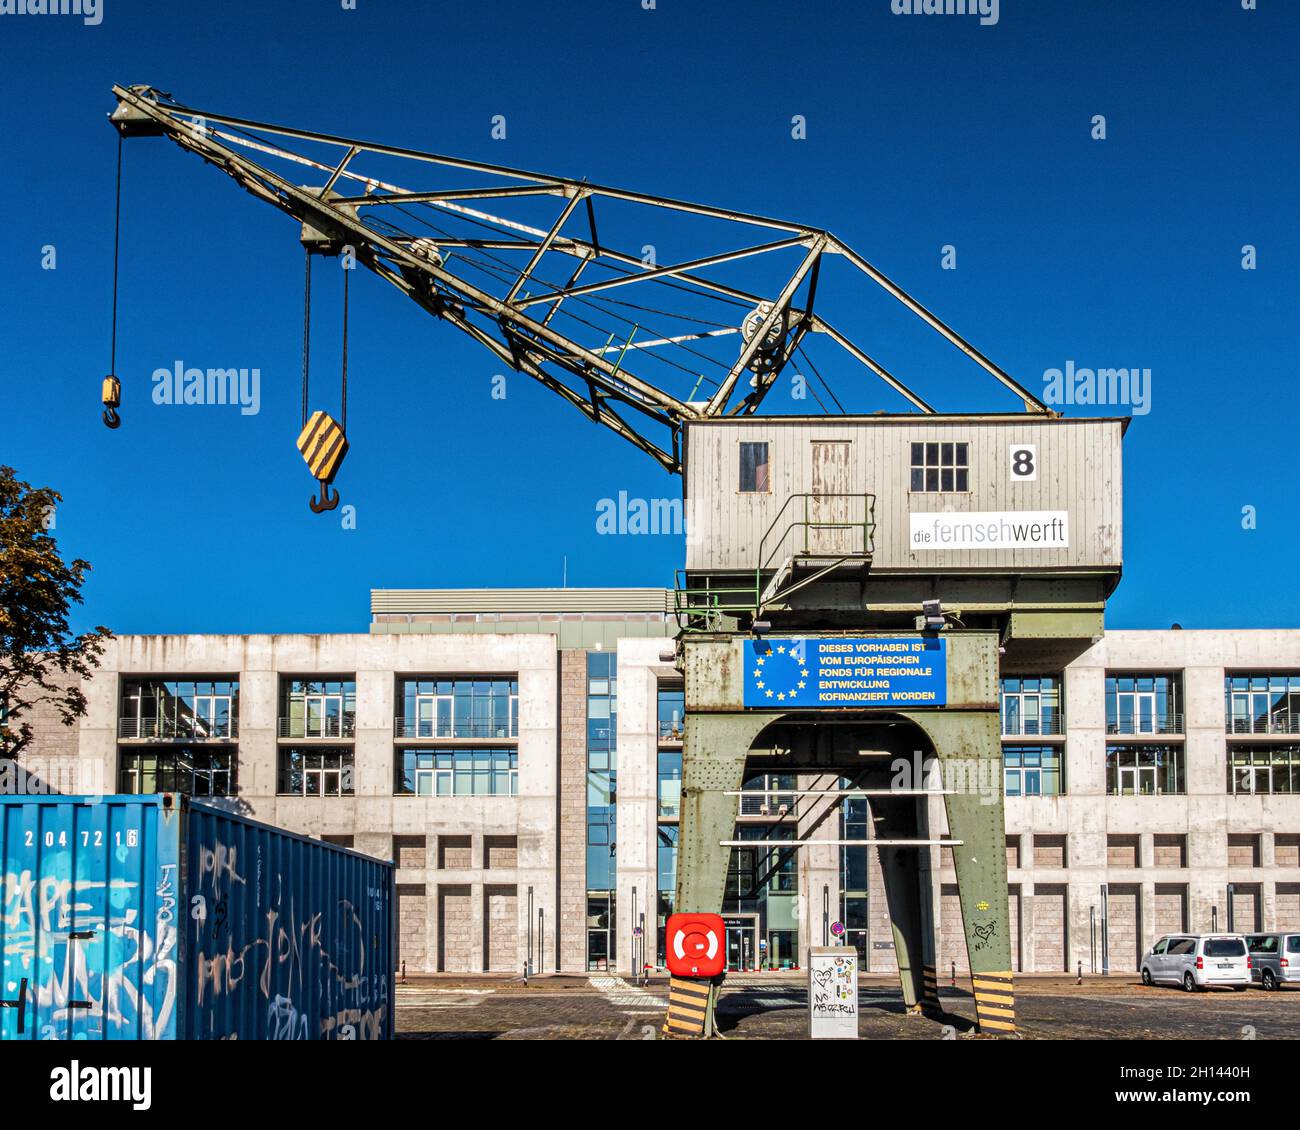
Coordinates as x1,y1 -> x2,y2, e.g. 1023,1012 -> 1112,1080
744,636 -> 948,710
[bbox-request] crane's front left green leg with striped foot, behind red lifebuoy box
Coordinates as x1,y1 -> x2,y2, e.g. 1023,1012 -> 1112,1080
666,714 -> 771,1036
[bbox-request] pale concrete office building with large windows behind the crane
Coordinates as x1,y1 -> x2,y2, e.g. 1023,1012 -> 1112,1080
12,589 -> 1300,973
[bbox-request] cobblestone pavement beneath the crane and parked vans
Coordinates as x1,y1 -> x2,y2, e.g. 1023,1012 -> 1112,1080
397,974 -> 1300,1040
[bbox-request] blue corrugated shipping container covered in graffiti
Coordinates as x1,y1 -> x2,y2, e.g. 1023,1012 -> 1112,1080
0,795 -> 397,1040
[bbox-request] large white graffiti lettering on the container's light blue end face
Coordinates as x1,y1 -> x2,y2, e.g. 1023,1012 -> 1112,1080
0,860 -> 177,1039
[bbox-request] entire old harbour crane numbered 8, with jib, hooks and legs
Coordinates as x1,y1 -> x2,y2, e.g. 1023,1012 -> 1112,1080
103,86 -> 1127,1036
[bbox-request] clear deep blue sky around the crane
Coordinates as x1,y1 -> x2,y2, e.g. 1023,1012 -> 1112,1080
0,0 -> 1300,632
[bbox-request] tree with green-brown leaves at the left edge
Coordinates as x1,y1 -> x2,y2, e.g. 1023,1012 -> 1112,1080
0,466 -> 113,757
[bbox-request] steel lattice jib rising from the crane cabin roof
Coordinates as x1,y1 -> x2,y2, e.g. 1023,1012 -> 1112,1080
111,86 -> 1053,472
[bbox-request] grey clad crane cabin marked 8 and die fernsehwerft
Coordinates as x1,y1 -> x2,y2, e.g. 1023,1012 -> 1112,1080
679,414 -> 1128,657
